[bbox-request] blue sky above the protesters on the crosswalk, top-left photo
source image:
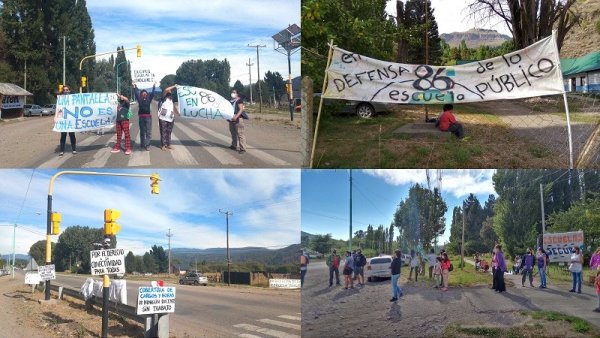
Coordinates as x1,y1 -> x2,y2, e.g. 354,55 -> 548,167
87,0 -> 300,85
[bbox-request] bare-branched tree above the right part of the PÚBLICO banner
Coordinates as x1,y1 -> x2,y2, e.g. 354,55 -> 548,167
469,0 -> 579,50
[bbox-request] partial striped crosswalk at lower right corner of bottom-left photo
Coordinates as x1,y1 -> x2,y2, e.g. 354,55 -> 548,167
233,313 -> 301,338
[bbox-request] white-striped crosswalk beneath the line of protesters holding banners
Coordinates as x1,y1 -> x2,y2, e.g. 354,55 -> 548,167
37,121 -> 300,168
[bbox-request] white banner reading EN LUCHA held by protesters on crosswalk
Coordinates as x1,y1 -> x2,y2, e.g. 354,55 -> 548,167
177,86 -> 233,120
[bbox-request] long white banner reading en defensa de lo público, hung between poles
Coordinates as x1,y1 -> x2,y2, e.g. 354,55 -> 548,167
323,36 -> 564,104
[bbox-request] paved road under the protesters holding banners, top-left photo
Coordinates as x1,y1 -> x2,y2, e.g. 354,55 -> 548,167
0,105 -> 301,168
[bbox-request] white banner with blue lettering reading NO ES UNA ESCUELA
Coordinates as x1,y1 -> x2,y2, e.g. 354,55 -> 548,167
52,93 -> 118,132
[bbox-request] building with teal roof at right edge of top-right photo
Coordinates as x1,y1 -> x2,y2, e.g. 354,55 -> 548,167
560,50 -> 600,93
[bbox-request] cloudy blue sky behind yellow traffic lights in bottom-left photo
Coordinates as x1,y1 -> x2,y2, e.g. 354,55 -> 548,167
0,169 -> 300,254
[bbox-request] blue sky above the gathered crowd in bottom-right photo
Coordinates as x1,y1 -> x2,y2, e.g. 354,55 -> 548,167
302,169 -> 495,247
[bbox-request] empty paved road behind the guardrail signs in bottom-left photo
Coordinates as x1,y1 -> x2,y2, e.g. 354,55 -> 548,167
53,274 -> 300,338
